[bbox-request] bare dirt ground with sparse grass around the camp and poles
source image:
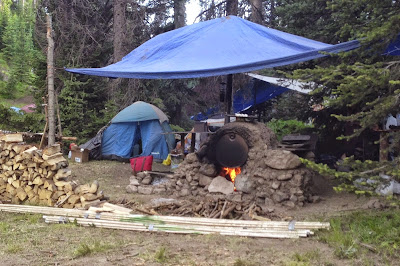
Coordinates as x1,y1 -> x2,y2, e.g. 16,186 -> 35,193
0,161 -> 386,266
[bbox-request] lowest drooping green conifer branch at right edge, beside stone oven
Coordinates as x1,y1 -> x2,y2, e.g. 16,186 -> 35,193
300,157 -> 400,195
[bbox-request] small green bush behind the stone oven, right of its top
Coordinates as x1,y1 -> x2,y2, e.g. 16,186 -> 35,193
267,119 -> 313,140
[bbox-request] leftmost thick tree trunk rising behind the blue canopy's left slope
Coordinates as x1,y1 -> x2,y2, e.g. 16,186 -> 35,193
113,0 -> 126,63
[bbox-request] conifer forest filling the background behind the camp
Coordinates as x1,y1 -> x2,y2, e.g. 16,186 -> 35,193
0,0 -> 400,164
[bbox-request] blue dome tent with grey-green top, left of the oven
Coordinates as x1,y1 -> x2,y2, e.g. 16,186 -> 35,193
80,101 -> 175,160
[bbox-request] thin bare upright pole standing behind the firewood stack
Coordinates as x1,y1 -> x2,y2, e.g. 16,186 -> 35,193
46,14 -> 56,145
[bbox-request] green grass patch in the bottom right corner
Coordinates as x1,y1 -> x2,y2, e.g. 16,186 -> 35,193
317,210 -> 400,259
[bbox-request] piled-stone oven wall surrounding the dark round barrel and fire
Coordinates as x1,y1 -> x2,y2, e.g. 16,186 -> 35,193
128,122 -> 313,208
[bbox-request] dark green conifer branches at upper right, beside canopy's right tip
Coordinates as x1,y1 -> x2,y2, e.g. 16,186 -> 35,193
282,0 -> 400,139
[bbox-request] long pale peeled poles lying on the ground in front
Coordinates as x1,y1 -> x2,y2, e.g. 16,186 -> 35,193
0,203 -> 330,238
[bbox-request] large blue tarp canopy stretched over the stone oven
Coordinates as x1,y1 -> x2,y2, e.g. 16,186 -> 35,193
66,16 -> 360,79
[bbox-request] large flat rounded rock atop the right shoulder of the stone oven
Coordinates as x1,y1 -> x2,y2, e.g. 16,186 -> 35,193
265,150 -> 301,170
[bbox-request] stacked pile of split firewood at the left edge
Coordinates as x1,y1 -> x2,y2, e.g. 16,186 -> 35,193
0,134 -> 104,208
